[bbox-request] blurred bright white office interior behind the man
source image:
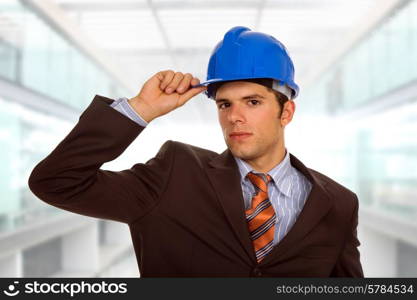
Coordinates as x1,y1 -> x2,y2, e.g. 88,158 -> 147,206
0,0 -> 417,277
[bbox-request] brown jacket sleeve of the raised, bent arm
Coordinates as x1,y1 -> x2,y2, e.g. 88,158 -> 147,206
28,95 -> 174,223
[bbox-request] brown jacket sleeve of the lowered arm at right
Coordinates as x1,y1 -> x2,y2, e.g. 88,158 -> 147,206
331,195 -> 364,277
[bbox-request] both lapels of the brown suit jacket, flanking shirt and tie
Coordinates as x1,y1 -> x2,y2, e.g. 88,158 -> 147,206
206,150 -> 333,265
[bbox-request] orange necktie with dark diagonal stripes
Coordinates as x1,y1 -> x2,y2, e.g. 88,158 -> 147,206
246,172 -> 276,263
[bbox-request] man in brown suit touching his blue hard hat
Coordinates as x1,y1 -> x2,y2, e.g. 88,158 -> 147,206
29,27 -> 363,277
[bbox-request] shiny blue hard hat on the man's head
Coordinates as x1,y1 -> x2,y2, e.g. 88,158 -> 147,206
199,26 -> 299,98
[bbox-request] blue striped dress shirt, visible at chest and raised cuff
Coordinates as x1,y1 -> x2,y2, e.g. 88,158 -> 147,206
111,98 -> 312,245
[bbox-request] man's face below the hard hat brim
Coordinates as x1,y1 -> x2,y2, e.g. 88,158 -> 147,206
215,81 -> 292,160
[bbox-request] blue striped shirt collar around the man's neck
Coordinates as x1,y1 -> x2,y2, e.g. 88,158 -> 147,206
233,149 -> 292,197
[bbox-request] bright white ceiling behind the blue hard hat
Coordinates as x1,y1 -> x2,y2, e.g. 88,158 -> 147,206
53,0 -> 381,91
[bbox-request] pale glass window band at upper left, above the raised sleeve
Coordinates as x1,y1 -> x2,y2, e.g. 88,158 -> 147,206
4,2 -> 127,110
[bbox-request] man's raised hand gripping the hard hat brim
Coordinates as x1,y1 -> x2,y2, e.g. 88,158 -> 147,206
129,70 -> 207,122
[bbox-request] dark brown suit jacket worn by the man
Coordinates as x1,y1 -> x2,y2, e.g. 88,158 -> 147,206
29,96 -> 363,277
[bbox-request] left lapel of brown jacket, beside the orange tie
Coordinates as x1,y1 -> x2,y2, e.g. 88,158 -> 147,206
206,150 -> 256,264
